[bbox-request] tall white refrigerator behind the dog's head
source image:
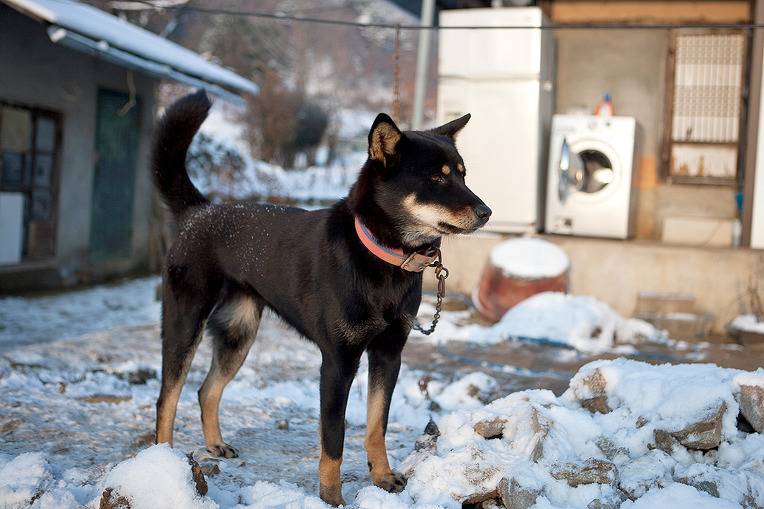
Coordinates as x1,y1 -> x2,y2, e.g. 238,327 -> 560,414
438,7 -> 554,232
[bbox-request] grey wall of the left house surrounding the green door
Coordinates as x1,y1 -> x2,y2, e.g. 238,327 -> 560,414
0,5 -> 156,287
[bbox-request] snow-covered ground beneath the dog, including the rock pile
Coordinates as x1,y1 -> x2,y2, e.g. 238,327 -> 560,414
0,278 -> 752,509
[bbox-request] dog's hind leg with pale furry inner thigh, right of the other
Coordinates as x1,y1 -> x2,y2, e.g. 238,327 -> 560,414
199,290 -> 263,458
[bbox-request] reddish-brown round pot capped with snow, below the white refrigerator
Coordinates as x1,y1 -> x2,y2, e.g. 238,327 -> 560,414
472,237 -> 570,322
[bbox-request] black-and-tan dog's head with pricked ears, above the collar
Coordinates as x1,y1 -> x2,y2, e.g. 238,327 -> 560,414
352,113 -> 491,246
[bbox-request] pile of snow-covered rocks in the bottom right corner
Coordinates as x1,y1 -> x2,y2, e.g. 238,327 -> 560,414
404,359 -> 764,509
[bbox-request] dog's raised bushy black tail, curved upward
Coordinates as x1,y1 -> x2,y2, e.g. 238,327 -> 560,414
151,90 -> 212,219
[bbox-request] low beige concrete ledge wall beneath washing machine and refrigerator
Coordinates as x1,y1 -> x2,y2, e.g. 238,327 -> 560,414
426,233 -> 764,332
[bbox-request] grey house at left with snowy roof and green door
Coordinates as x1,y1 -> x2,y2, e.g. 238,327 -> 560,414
0,0 -> 257,292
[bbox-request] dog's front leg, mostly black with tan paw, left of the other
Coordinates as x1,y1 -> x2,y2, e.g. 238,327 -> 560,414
318,351 -> 361,506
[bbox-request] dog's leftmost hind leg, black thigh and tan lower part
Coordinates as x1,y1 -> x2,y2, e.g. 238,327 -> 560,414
156,269 -> 219,445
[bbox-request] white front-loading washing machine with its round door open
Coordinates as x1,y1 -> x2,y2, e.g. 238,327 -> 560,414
545,115 -> 637,239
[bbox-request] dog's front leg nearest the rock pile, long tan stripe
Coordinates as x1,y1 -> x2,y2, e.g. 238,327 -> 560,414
365,324 -> 409,493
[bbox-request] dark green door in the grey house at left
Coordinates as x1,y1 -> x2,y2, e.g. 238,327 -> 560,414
90,89 -> 140,262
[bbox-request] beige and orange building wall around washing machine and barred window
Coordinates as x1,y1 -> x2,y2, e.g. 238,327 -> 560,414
548,1 -> 749,239
